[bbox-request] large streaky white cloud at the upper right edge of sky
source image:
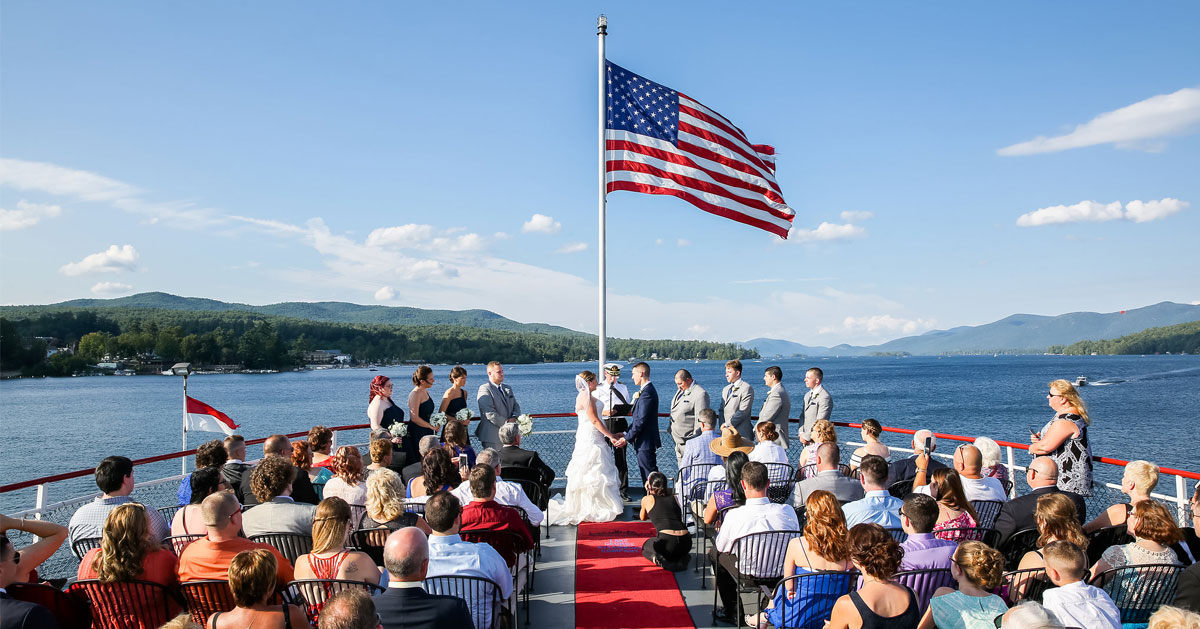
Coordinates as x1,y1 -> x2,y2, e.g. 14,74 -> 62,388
996,88 -> 1200,156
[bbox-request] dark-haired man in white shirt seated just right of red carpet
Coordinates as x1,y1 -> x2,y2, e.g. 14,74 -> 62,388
709,461 -> 800,623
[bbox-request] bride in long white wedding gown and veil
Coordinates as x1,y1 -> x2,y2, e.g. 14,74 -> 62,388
547,371 -> 625,525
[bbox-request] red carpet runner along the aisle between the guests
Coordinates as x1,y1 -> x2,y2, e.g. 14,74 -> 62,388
575,522 -> 695,629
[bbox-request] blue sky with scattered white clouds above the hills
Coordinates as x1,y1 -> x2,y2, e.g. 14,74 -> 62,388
0,0 -> 1200,345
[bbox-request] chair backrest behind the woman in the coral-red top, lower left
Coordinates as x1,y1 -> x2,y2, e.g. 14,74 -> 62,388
67,579 -> 180,629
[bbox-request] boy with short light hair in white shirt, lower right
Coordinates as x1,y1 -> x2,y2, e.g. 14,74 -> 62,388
1042,540 -> 1121,629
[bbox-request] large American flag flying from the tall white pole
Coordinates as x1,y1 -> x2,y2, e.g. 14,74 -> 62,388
605,61 -> 796,239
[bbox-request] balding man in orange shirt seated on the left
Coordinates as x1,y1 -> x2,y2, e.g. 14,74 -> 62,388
179,491 -> 293,588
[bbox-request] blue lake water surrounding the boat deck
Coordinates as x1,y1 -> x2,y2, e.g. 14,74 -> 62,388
0,355 -> 1200,513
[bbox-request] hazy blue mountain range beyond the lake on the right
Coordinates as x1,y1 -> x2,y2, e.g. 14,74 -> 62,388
742,301 -> 1200,357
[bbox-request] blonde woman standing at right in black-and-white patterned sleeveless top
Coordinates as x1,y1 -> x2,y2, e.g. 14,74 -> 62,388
1030,381 -> 1092,496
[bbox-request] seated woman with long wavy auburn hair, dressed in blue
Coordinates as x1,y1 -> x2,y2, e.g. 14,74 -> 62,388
746,490 -> 856,629
